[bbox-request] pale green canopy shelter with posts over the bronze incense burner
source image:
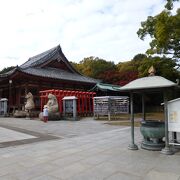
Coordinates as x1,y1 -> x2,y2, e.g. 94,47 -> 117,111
119,72 -> 178,155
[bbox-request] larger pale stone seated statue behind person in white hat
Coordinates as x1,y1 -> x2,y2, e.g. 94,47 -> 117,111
45,93 -> 59,113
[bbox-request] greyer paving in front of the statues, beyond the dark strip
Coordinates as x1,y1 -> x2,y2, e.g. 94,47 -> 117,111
0,118 -> 119,138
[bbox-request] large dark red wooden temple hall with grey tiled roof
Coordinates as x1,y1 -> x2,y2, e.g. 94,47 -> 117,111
0,45 -> 97,109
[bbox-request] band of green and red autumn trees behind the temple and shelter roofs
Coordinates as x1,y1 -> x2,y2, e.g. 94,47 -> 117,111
72,54 -> 180,86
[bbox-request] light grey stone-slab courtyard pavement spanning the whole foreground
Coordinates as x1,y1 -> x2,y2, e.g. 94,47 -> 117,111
0,118 -> 180,180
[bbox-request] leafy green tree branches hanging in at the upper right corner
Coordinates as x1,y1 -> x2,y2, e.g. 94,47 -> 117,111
137,0 -> 180,62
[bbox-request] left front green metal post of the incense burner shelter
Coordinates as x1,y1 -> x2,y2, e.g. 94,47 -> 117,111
128,92 -> 138,150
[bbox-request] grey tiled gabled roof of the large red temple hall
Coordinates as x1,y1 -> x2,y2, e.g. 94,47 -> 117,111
0,45 -> 98,84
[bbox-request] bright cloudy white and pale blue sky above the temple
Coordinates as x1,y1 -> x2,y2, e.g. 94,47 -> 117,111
0,0 -> 179,69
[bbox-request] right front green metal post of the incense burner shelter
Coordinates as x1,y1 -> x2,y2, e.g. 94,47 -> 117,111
161,90 -> 174,155
